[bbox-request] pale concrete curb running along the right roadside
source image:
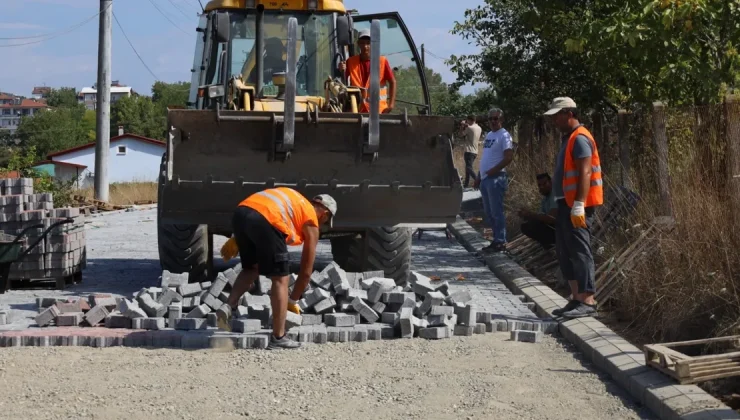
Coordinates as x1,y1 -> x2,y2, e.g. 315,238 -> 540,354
449,217 -> 740,420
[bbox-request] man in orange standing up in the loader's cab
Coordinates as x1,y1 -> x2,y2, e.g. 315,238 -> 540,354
339,29 -> 396,114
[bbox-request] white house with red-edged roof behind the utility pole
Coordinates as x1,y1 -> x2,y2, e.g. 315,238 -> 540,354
34,134 -> 166,188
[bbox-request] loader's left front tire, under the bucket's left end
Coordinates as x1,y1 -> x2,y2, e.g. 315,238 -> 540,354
157,153 -> 211,283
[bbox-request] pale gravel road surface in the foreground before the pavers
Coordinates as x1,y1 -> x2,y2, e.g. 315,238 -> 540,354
0,333 -> 649,420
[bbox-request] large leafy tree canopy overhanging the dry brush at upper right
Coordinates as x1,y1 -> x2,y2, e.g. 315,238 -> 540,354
449,0 -> 740,119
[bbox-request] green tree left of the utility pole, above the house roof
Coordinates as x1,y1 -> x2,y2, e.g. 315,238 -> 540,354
16,107 -> 89,160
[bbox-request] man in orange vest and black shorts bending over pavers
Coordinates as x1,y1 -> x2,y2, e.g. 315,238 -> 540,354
216,187 -> 337,349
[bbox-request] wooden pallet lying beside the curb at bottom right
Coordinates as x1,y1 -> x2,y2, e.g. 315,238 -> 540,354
643,335 -> 740,385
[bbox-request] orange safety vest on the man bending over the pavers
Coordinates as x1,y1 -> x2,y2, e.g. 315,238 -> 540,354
239,187 -> 319,246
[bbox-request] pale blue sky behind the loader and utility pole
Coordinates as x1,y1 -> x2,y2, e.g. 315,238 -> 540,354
0,0 -> 482,96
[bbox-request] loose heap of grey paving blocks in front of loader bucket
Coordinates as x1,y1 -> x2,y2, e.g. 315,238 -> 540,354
36,263 -> 553,343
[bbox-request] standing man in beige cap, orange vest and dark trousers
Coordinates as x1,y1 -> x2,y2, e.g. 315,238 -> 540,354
545,97 -> 604,319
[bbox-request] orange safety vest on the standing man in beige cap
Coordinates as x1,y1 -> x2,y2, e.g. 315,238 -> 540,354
563,126 -> 604,207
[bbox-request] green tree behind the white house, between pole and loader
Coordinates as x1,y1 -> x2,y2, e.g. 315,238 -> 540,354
111,96 -> 166,140
